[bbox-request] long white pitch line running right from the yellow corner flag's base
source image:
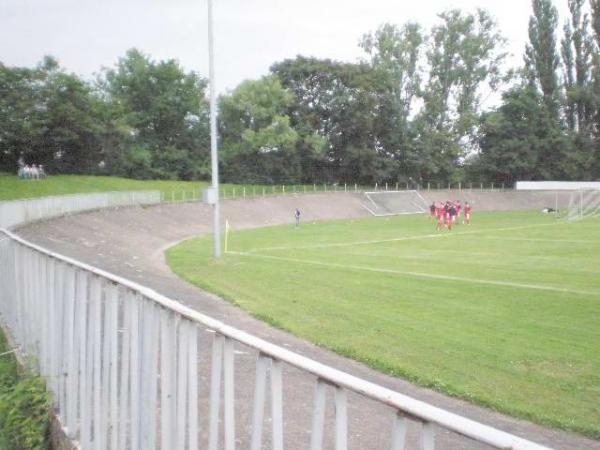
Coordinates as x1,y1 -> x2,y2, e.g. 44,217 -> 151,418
228,251 -> 600,296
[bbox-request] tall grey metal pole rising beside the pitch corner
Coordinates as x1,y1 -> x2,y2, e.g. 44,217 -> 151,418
208,0 -> 221,258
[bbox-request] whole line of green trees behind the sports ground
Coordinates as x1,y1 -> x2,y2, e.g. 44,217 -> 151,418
0,0 -> 600,184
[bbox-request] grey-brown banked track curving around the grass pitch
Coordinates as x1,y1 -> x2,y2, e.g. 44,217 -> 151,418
18,194 -> 600,450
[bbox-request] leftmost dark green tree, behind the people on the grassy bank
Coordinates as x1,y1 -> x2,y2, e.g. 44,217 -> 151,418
0,57 -> 103,173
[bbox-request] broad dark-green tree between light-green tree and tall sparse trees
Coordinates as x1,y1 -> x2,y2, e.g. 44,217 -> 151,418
271,56 -> 380,183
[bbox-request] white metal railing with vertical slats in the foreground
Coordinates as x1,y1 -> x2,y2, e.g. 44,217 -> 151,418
0,230 -> 546,450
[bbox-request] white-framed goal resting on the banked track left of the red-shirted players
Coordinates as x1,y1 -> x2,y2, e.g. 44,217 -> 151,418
364,191 -> 429,216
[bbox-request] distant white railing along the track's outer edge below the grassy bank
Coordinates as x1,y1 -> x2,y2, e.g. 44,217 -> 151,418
0,191 -> 161,228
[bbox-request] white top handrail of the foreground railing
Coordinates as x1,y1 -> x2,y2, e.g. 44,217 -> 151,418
0,229 -> 548,450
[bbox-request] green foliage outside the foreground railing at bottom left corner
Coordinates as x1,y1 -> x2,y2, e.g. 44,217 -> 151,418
0,333 -> 51,450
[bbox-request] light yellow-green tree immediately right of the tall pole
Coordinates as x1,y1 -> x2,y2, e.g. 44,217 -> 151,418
219,76 -> 300,183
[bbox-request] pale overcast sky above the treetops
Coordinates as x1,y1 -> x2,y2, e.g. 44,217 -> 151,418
0,0 -> 567,95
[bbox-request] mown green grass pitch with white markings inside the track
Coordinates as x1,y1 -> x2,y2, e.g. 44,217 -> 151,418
167,212 -> 600,438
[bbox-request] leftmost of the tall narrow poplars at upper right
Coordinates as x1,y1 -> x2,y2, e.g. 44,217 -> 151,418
525,0 -> 559,118
